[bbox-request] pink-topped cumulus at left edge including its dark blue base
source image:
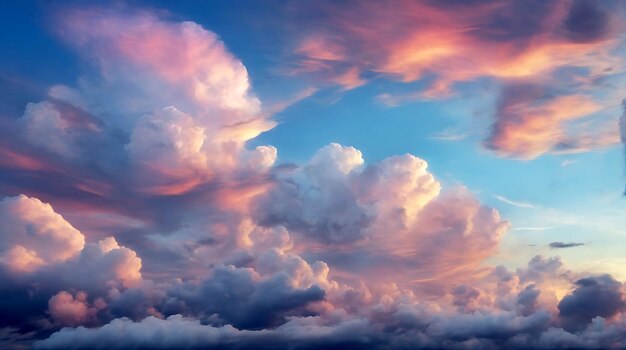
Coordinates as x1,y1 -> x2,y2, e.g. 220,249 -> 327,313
0,195 -> 142,327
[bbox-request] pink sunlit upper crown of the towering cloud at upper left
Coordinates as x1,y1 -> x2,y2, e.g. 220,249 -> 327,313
58,8 -> 260,116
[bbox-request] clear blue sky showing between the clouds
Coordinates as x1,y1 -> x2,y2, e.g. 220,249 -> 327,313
0,0 -> 626,270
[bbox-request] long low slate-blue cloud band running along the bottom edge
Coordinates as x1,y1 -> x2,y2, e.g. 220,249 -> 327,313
29,311 -> 550,349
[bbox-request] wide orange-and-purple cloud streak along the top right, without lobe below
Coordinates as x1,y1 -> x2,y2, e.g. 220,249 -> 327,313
295,1 -> 620,88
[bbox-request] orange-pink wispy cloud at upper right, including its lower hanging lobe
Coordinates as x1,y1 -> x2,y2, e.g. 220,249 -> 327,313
294,1 -> 624,159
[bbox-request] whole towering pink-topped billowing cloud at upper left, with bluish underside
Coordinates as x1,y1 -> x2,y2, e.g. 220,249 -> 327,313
3,7 -> 276,195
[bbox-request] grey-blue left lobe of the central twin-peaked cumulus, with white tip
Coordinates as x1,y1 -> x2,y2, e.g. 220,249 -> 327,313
252,144 -> 372,243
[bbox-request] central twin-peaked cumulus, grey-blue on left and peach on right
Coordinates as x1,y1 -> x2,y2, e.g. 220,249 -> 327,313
256,143 -> 440,243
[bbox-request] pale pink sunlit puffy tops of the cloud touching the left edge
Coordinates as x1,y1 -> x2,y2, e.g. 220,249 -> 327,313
0,195 -> 142,289
